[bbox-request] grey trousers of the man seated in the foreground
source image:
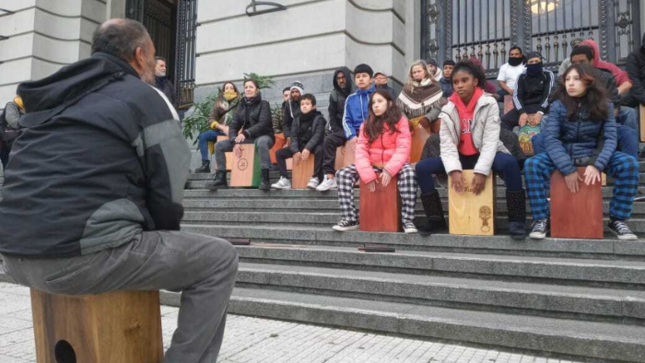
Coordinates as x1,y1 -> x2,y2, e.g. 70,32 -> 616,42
4,231 -> 238,363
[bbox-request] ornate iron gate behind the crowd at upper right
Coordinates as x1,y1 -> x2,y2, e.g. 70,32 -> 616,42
421,0 -> 640,74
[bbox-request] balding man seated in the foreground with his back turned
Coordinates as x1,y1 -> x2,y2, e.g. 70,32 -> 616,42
0,19 -> 237,363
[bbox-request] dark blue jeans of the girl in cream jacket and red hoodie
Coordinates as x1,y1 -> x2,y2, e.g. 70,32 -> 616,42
416,152 -> 523,195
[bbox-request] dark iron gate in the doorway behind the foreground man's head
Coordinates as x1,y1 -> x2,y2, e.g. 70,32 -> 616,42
126,0 -> 197,108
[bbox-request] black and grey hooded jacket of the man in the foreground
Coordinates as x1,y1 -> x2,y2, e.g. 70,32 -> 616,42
0,53 -> 190,257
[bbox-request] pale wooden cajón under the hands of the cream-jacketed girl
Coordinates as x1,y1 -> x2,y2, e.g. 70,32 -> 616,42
448,170 -> 495,236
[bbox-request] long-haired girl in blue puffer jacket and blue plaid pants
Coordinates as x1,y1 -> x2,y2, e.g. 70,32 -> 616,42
524,65 -> 638,240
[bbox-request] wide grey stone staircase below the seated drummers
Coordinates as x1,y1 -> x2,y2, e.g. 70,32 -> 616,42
176,168 -> 645,362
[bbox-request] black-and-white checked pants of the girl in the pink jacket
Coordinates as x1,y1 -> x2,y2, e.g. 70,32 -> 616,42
336,163 -> 417,224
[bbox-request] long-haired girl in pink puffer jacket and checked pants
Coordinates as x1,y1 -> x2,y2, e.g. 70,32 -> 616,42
333,90 -> 417,233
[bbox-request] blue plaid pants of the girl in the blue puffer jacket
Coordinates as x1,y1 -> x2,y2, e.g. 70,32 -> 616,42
524,151 -> 638,221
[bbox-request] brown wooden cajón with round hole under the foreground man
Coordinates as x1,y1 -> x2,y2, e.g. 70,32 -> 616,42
31,289 -> 164,363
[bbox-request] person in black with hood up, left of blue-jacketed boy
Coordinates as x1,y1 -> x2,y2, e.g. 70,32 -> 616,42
323,67 -> 354,189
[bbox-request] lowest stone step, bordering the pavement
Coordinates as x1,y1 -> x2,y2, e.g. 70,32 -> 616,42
162,288 -> 645,362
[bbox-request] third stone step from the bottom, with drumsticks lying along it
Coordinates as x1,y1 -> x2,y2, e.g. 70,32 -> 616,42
237,243 -> 645,290
